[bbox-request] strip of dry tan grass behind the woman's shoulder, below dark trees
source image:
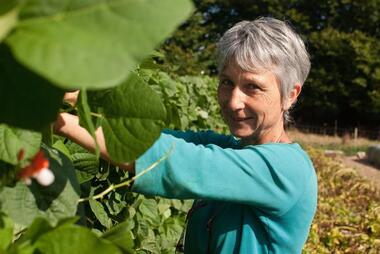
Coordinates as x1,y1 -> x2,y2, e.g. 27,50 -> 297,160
288,129 -> 380,156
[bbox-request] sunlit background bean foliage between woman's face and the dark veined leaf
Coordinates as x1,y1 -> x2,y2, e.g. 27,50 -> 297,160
139,66 -> 227,133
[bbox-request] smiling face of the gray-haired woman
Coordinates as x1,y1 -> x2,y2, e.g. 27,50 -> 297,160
218,63 -> 283,143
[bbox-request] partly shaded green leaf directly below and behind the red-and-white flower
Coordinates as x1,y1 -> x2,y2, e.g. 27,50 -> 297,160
0,145 -> 79,230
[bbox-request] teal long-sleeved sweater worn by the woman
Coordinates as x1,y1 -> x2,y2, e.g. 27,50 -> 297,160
132,131 -> 317,254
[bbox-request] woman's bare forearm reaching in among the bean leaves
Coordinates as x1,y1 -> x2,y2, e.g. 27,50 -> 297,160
53,113 -> 135,174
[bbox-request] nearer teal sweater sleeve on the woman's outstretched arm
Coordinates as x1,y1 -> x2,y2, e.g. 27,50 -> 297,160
132,133 -> 314,215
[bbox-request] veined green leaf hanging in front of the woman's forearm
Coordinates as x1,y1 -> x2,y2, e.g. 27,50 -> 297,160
91,74 -> 166,162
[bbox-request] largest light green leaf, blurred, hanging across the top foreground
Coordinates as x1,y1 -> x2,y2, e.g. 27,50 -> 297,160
6,0 -> 192,88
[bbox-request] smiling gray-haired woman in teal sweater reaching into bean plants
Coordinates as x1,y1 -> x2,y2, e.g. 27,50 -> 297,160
56,18 -> 317,254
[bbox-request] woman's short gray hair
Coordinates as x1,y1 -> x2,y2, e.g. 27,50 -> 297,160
217,17 -> 310,123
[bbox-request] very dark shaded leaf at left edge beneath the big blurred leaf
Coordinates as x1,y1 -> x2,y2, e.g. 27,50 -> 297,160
0,45 -> 64,130
